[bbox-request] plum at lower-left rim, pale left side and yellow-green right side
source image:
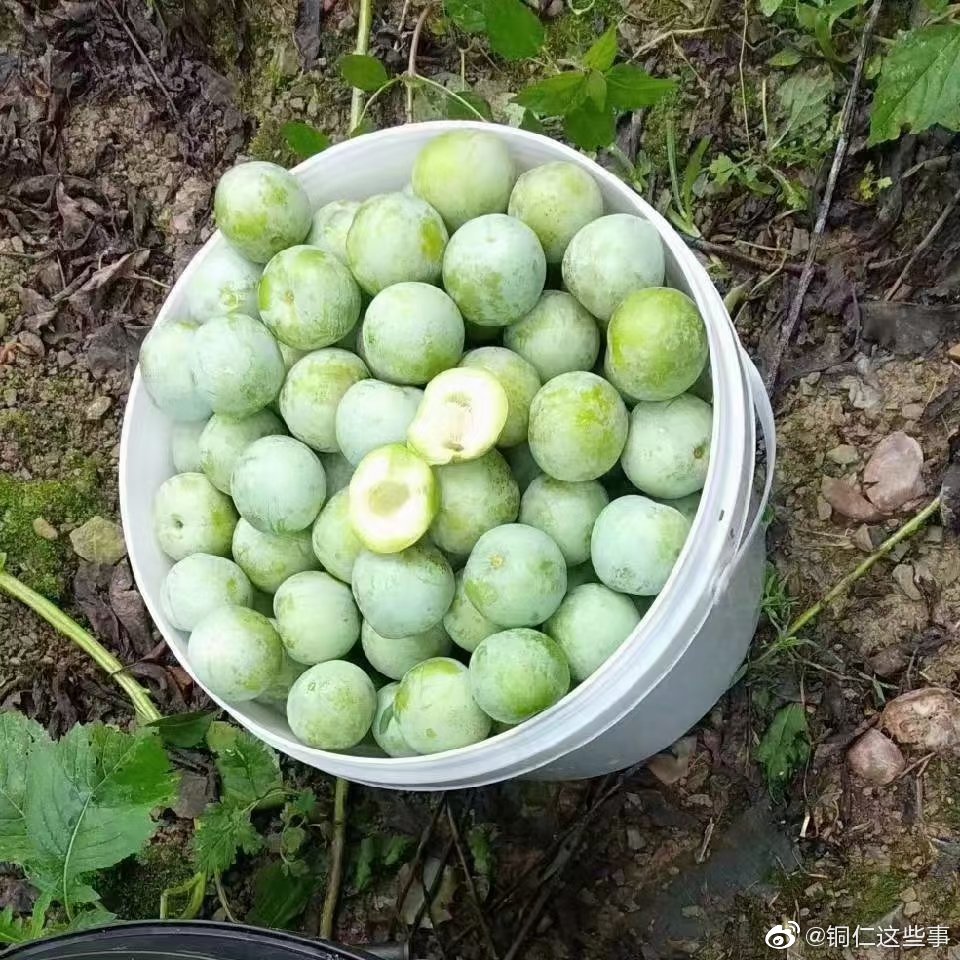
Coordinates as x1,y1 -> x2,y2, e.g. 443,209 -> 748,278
187,606 -> 283,703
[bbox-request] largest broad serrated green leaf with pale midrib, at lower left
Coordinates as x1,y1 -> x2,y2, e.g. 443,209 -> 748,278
25,724 -> 176,903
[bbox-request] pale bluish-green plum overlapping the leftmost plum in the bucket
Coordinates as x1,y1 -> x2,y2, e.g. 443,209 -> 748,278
192,313 -> 286,417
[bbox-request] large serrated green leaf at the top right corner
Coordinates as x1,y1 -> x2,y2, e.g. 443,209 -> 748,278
870,23 -> 960,144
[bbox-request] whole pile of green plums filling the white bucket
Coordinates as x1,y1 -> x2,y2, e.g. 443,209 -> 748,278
140,130 -> 713,757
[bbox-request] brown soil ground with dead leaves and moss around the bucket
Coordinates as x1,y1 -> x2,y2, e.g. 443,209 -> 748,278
0,0 -> 960,960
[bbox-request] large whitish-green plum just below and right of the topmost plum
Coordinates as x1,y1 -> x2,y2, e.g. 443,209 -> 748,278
443,213 -> 547,327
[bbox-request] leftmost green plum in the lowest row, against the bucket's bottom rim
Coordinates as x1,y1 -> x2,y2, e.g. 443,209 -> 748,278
287,660 -> 377,750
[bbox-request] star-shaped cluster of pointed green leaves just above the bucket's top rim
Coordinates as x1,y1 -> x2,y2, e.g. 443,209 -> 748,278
514,25 -> 676,150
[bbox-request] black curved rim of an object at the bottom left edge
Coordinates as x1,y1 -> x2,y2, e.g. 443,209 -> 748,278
0,920 -> 384,960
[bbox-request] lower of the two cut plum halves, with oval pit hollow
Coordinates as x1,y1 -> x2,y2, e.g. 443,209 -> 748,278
348,443 -> 440,553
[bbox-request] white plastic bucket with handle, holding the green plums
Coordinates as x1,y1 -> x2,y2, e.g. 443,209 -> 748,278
120,121 -> 774,790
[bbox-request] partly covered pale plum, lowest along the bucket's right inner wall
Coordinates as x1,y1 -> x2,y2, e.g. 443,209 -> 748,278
543,583 -> 640,681
